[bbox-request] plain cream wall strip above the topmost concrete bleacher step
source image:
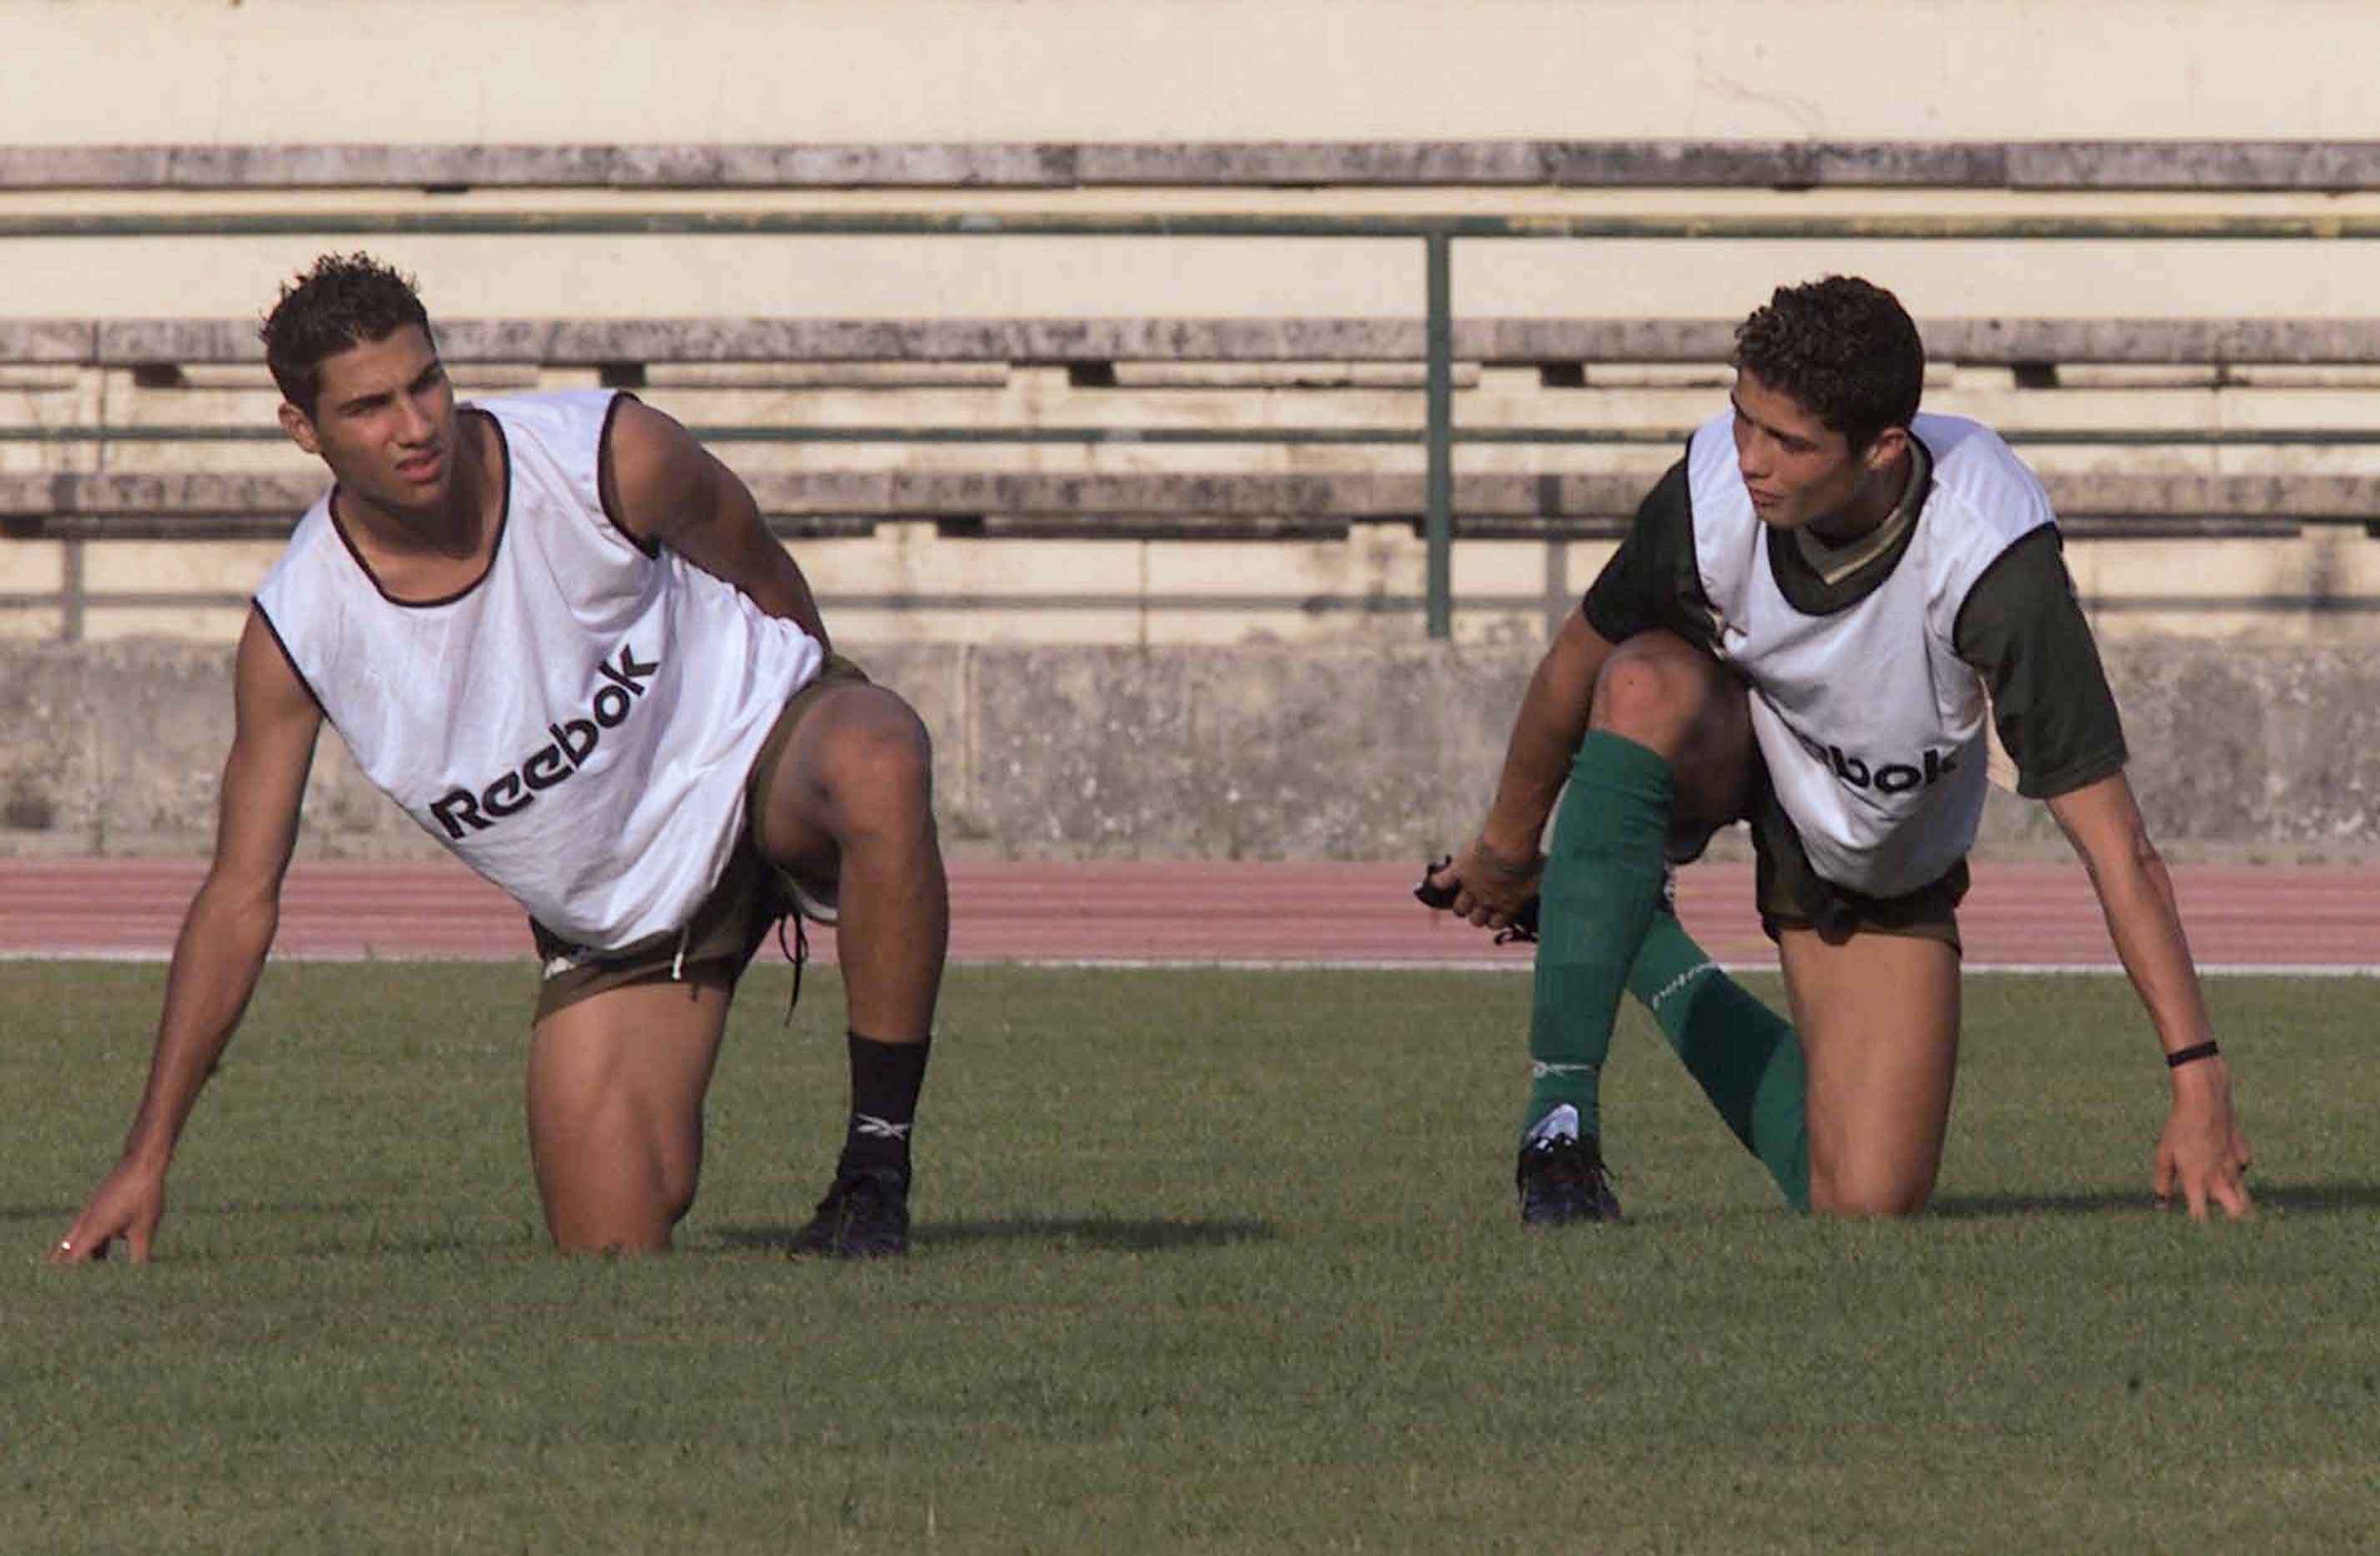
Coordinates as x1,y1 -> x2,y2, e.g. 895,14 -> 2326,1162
13,0 -> 2380,143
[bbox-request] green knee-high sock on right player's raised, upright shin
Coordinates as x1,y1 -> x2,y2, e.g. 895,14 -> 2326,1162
1521,731 -> 1674,1139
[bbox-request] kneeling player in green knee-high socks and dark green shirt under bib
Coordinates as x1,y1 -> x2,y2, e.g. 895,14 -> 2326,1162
1436,276 -> 2251,1223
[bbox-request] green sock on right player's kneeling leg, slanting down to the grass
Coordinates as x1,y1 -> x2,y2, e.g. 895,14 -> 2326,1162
1628,906 -> 1809,1211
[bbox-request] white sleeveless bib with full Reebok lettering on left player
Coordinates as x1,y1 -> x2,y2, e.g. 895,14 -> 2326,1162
257,390 -> 823,950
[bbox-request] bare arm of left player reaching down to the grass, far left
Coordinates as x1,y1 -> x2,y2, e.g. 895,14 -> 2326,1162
50,611 -> 322,1264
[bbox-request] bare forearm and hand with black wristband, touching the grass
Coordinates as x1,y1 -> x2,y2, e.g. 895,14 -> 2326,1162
2049,773 -> 2254,1220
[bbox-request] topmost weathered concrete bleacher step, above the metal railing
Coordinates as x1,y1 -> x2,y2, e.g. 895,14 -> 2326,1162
13,138 -> 2380,193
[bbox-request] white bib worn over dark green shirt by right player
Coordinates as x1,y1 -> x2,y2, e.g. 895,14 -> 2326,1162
1688,412 -> 2054,897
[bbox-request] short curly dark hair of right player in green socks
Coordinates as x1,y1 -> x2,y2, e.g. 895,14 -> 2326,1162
1735,276 -> 1926,452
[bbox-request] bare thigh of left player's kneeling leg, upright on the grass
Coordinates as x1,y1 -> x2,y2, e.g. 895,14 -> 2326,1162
529,973 -> 731,1251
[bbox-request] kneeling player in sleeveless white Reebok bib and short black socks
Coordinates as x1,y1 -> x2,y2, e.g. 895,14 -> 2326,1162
50,255 -> 949,1264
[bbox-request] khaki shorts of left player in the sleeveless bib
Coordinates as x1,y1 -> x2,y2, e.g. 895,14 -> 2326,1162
529,654 -> 866,1021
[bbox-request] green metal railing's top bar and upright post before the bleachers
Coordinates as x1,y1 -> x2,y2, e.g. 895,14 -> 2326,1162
13,210 -> 2380,637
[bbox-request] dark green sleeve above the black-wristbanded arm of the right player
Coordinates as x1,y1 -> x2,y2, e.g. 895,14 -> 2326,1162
1952,526 -> 2125,799
